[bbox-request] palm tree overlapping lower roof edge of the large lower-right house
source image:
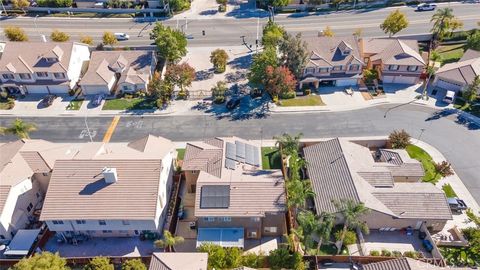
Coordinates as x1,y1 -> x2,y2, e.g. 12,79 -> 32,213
333,199 -> 370,254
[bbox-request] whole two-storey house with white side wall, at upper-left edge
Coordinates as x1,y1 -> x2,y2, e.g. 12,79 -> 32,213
0,42 -> 90,94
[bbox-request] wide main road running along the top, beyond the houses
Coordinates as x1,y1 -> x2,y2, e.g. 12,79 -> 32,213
0,3 -> 480,46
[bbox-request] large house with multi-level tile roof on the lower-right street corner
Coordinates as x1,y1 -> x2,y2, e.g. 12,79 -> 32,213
303,138 -> 452,231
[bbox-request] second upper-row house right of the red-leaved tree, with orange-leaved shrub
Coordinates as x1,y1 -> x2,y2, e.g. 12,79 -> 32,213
360,38 -> 425,84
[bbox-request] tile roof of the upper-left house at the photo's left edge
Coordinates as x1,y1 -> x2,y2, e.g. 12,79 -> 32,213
0,42 -> 75,73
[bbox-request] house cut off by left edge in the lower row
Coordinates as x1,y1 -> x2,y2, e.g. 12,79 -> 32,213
0,140 -> 75,240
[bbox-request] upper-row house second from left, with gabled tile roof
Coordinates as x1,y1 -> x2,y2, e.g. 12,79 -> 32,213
80,50 -> 156,95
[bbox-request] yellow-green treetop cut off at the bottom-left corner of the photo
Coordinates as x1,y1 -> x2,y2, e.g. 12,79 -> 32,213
12,251 -> 70,270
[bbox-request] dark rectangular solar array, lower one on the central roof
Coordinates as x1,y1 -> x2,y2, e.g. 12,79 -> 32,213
200,185 -> 230,208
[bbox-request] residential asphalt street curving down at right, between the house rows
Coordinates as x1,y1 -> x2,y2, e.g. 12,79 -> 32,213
0,105 -> 480,202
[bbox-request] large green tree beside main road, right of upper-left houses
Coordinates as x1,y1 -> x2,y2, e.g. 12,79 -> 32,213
150,22 -> 187,63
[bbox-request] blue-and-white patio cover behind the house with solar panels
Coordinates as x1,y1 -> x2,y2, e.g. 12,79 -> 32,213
197,228 -> 244,248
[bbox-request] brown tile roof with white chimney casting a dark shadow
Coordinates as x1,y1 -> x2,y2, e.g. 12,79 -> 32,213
40,159 -> 162,220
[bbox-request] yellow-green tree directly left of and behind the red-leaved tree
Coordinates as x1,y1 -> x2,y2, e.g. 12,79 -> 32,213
248,47 -> 278,86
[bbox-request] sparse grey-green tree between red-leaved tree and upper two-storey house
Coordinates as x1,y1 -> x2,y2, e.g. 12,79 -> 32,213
279,33 -> 309,78
